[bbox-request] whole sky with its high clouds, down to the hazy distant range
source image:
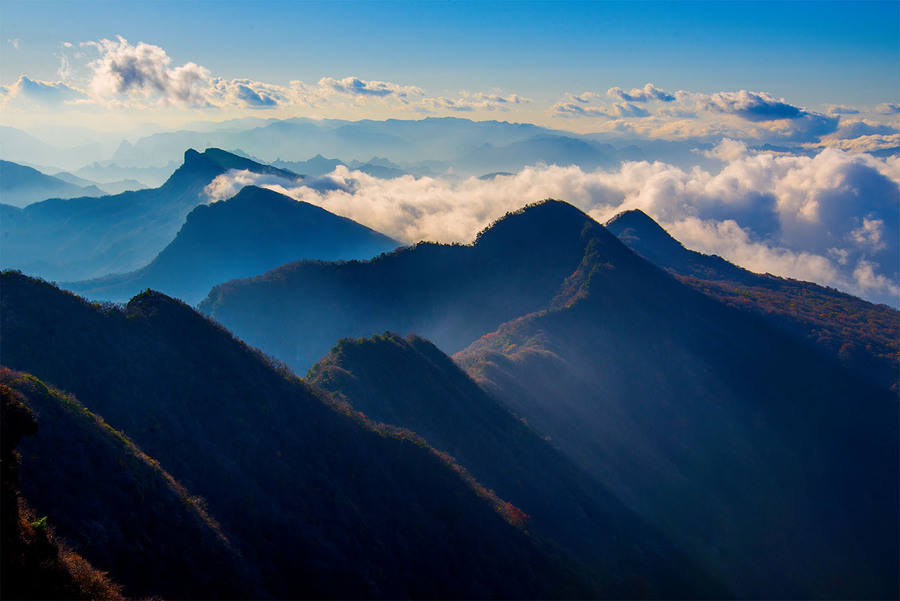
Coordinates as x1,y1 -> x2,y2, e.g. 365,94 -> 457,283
0,0 -> 900,132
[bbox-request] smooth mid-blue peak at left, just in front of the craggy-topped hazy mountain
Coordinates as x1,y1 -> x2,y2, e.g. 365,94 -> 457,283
64,186 -> 400,304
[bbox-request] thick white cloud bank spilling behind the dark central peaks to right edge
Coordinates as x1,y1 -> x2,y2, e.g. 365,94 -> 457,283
208,148 -> 900,306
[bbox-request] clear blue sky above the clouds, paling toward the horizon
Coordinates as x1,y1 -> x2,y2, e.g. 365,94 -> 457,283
0,0 -> 900,131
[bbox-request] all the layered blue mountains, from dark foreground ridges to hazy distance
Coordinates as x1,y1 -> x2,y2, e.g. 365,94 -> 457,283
0,146 -> 900,599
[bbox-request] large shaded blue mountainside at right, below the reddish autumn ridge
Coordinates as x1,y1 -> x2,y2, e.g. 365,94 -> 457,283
455,223 -> 900,598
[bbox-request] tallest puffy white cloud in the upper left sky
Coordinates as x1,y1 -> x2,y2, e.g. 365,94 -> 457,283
85,36 -> 209,106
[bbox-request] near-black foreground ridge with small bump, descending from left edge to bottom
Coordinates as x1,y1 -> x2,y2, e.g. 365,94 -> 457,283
0,272 -> 596,598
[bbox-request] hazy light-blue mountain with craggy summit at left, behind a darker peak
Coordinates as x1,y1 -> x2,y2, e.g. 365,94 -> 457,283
0,148 -> 296,281
